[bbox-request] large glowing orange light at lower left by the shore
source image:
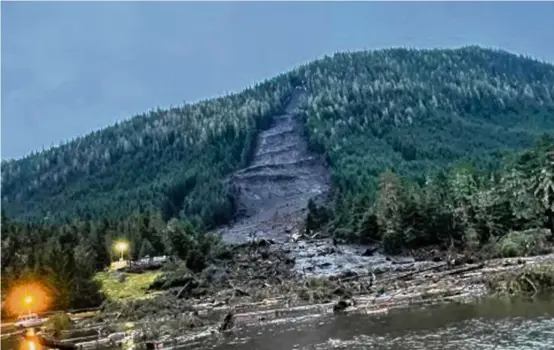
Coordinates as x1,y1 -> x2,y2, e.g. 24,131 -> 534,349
6,282 -> 50,315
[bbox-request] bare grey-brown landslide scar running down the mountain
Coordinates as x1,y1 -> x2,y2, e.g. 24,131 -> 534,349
220,89 -> 331,243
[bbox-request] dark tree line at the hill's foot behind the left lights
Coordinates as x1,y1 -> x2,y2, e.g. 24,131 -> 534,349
1,212 -> 226,312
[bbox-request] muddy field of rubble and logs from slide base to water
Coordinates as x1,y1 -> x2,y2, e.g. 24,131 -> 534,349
85,241 -> 554,348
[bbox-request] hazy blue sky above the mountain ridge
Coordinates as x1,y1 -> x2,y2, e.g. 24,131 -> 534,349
1,2 -> 554,159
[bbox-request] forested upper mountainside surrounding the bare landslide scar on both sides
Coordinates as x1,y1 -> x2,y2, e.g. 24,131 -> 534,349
2,47 -> 554,227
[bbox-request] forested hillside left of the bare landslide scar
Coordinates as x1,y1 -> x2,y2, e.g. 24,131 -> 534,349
2,77 -> 290,227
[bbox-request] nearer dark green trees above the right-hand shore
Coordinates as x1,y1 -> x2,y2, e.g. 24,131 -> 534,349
356,137 -> 554,257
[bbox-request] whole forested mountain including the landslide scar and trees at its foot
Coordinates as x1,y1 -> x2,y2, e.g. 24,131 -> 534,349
1,47 -> 554,318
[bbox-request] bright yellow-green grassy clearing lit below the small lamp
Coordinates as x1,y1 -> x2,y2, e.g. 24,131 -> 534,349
95,271 -> 161,301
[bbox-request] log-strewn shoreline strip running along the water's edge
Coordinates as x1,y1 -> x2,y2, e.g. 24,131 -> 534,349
90,241 -> 554,348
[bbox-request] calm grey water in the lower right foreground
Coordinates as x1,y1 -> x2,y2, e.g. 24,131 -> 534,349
206,296 -> 554,350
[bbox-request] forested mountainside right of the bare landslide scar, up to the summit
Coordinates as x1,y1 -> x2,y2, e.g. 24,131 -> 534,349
295,47 -> 554,239
